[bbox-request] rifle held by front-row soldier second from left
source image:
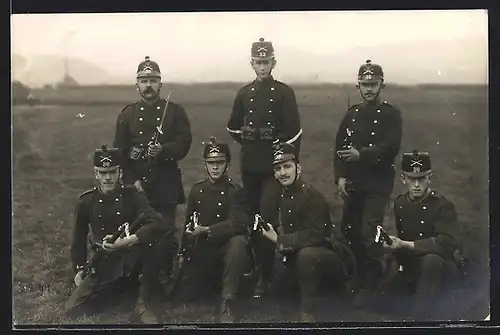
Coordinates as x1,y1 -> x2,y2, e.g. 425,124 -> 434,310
167,211 -> 198,298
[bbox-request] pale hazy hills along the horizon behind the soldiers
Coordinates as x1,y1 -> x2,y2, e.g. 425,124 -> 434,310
12,39 -> 488,87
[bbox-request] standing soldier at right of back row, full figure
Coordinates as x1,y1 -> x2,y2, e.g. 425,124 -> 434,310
334,60 -> 402,304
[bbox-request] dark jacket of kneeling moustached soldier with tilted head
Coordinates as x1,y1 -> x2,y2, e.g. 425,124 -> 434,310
277,179 -> 345,253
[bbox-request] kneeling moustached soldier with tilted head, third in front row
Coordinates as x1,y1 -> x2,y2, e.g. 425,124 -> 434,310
260,143 -> 355,322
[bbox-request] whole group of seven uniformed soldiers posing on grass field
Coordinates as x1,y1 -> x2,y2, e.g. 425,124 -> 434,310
65,38 -> 462,324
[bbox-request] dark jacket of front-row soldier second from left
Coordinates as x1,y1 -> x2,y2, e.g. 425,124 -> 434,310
186,177 -> 251,242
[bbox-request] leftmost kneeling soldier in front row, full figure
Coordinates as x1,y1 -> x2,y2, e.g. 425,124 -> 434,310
65,146 -> 168,323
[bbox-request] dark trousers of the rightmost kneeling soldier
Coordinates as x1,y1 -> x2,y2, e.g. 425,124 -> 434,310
382,254 -> 459,321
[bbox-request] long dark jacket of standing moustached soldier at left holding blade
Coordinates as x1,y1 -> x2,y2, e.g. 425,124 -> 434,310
114,99 -> 192,205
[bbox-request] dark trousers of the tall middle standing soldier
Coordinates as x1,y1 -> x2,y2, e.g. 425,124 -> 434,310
241,169 -> 281,279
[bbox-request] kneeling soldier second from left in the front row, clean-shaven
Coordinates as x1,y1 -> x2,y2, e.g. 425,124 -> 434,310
172,137 -> 250,322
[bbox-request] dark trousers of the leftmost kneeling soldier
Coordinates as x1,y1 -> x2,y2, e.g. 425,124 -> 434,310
65,245 -> 158,317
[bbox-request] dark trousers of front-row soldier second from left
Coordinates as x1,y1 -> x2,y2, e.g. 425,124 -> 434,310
179,235 -> 247,301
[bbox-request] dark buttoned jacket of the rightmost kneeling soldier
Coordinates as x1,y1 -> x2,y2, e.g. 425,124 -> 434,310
394,191 -> 460,266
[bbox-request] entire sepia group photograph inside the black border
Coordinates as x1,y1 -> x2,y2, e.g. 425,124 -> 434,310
11,10 -> 490,328
